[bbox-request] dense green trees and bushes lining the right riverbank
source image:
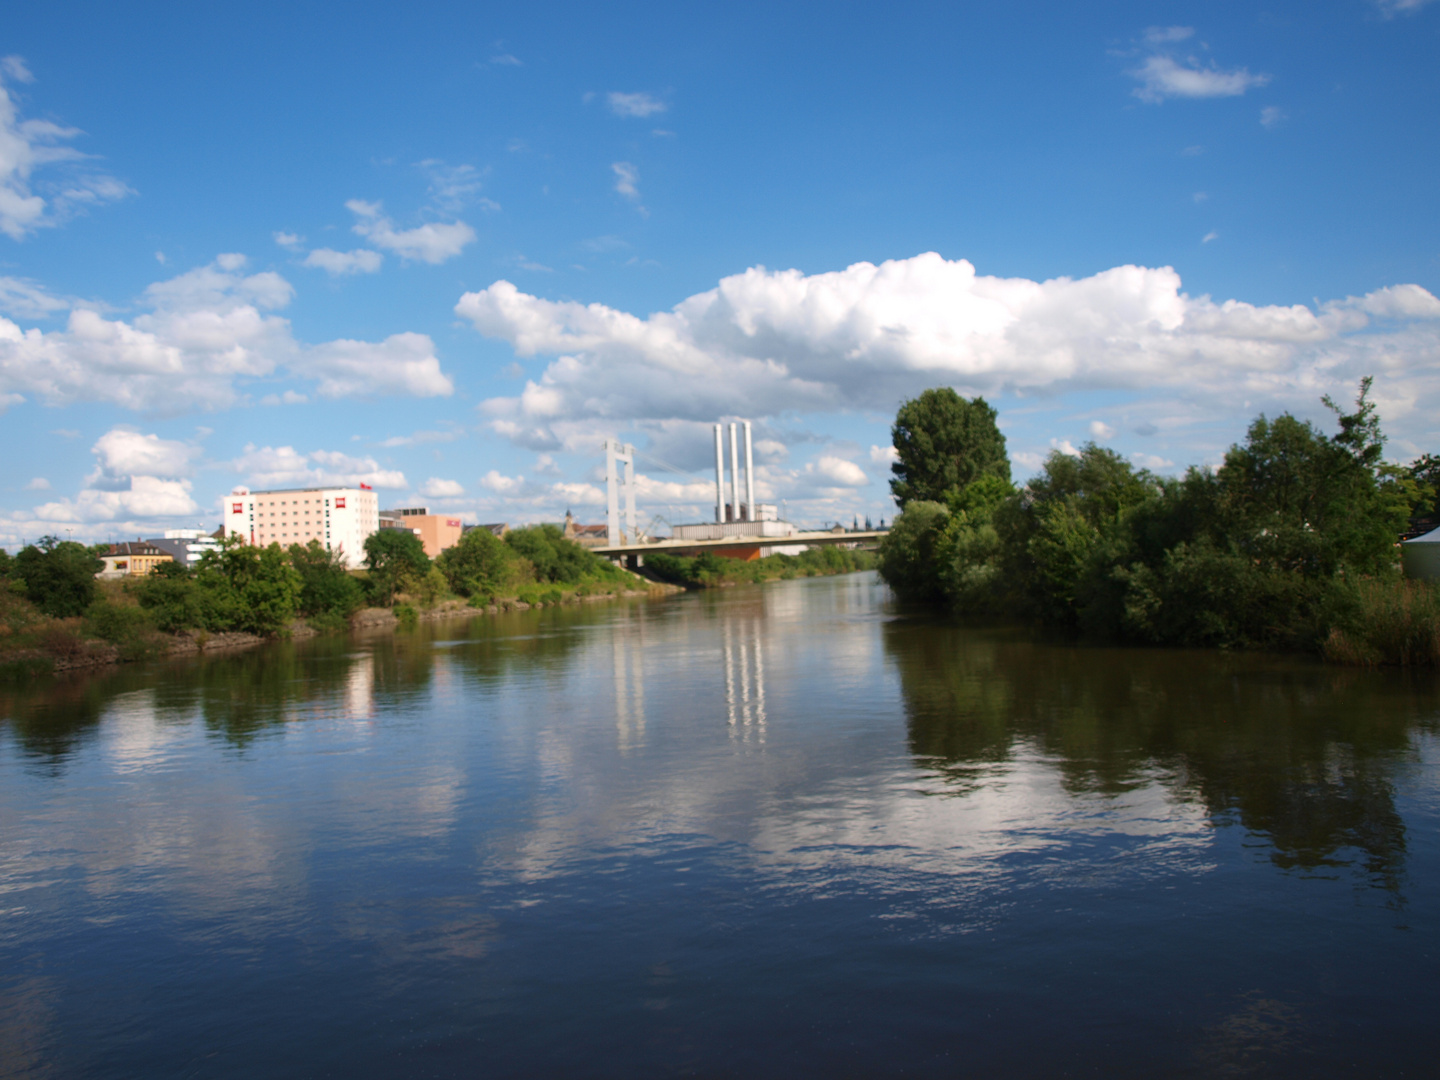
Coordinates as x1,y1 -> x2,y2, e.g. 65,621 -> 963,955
878,379 -> 1440,664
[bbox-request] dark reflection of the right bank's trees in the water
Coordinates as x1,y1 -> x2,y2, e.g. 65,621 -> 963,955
884,618 -> 1437,900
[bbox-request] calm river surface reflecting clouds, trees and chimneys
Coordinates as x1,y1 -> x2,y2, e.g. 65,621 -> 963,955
0,575 -> 1440,1077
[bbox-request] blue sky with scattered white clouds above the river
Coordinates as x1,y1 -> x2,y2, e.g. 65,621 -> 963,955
0,0 -> 1440,549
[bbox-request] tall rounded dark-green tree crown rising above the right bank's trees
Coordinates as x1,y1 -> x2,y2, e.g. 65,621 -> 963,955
890,386 -> 1009,510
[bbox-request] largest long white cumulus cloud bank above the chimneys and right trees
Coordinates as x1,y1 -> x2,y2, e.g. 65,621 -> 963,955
455,253 -> 1440,451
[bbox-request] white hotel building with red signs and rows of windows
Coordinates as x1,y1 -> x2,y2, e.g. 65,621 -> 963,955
225,487 -> 380,570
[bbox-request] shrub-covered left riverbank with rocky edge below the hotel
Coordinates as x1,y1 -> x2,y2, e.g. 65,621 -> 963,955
0,526 -> 675,678
